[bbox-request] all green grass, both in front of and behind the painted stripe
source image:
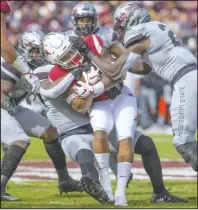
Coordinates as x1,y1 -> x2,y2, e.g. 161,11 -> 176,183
1,135 -> 197,209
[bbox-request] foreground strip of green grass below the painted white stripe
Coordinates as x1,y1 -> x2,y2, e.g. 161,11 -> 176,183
1,180 -> 197,209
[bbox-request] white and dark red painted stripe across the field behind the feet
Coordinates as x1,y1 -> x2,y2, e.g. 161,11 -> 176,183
8,159 -> 197,182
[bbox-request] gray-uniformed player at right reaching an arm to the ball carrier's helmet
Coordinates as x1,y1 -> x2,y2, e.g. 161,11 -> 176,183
71,1 -> 197,171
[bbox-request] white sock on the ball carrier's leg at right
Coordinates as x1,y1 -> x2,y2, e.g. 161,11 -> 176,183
115,162 -> 132,197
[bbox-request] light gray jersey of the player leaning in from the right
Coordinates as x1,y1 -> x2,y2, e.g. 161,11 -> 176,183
124,21 -> 197,84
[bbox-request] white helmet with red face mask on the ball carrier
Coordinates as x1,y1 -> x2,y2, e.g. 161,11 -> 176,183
43,32 -> 84,69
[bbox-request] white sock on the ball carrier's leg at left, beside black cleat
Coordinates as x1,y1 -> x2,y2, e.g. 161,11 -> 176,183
95,153 -> 113,198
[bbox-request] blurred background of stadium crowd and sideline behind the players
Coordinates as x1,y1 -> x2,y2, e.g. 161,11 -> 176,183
7,1 -> 197,132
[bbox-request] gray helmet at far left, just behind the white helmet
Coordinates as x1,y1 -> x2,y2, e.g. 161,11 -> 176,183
16,30 -> 46,67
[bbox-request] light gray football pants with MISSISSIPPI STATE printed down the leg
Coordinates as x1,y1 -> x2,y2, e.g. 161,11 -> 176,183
170,70 -> 197,147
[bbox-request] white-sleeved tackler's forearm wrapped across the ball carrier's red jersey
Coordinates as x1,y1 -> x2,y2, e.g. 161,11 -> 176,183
40,73 -> 75,98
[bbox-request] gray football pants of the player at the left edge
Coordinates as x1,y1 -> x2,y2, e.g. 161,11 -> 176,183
1,106 -> 51,145
